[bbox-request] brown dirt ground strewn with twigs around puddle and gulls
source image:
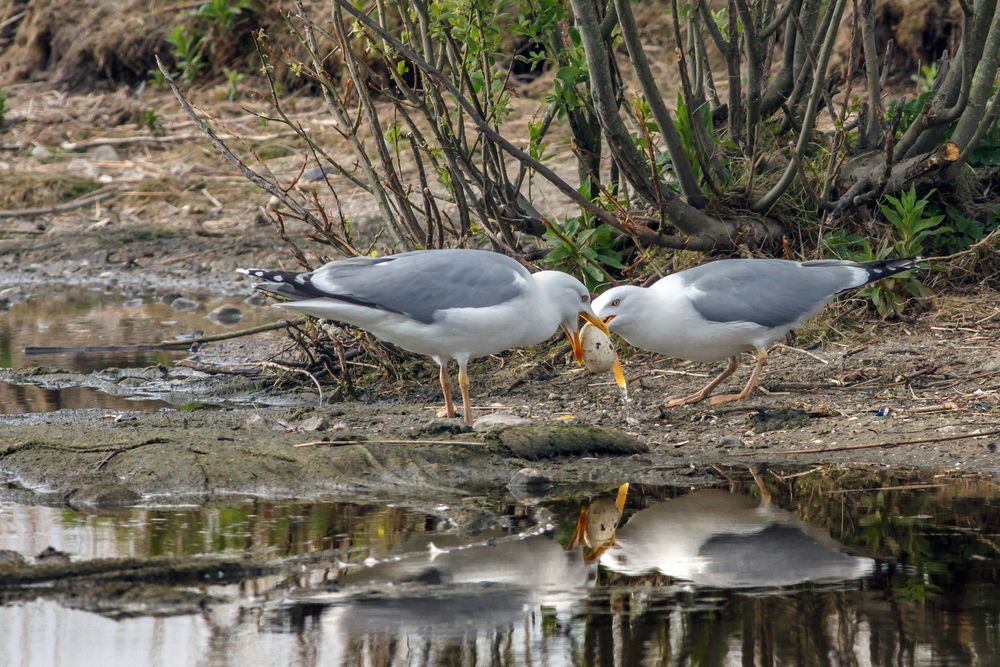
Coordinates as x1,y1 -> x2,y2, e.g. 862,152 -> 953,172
0,79 -> 1000,504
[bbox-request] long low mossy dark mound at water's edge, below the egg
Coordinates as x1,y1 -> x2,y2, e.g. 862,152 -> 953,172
493,424 -> 649,460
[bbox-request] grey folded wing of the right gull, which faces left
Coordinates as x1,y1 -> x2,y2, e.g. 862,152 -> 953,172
679,259 -> 867,327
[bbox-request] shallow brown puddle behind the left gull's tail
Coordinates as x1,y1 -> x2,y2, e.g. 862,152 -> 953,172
0,286 -> 281,414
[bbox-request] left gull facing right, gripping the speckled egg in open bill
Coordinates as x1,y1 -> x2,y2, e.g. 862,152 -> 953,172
237,249 -> 608,425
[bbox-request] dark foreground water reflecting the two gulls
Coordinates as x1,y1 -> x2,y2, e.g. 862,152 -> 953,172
0,471 -> 1000,667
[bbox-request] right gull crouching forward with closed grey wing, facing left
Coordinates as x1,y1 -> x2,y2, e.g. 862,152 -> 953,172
594,258 -> 920,407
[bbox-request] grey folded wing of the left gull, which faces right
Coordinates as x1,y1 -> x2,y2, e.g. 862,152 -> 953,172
305,249 -> 531,323
